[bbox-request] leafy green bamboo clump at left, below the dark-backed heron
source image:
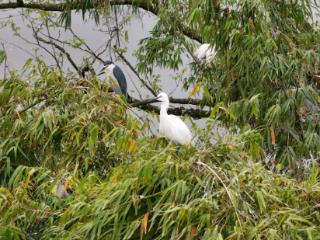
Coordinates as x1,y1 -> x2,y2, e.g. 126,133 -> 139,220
0,60 -> 139,181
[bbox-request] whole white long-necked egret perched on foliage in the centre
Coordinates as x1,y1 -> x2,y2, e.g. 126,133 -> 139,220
157,92 -> 192,145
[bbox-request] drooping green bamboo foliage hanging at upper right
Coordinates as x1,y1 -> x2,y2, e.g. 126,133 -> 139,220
132,0 -> 320,167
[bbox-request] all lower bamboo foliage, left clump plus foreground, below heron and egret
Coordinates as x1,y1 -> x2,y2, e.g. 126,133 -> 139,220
0,65 -> 320,239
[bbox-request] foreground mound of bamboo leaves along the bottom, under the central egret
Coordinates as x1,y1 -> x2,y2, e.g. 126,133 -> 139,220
0,132 -> 320,239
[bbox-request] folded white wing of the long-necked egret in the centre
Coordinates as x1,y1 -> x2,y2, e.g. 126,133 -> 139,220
167,115 -> 192,144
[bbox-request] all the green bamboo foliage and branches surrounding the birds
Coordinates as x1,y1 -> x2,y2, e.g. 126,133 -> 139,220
0,0 -> 320,239
